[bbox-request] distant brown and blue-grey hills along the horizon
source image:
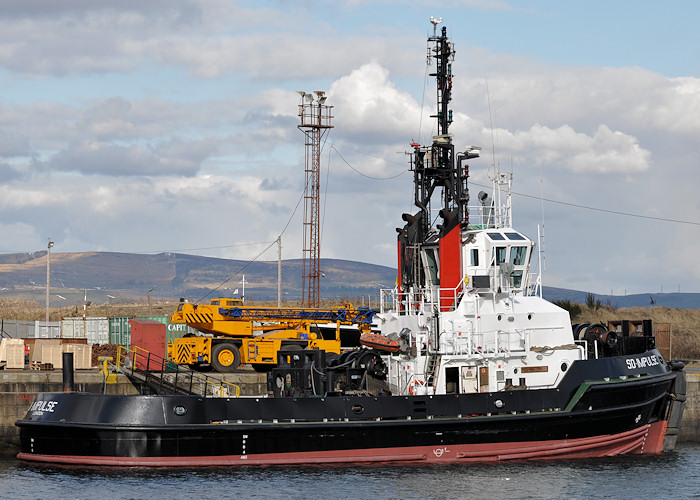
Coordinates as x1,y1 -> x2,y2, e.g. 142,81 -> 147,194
0,251 -> 700,309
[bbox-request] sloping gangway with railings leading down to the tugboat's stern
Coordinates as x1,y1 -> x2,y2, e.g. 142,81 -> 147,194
116,346 -> 241,398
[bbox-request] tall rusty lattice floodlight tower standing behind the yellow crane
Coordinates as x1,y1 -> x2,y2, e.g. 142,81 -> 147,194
298,90 -> 333,307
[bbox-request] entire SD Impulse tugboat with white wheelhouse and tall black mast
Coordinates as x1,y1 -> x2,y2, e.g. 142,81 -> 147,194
17,19 -> 685,466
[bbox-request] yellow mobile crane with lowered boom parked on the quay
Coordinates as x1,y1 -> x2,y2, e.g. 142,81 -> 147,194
167,298 -> 376,373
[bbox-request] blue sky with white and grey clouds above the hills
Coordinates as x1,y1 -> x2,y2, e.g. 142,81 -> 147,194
0,0 -> 700,295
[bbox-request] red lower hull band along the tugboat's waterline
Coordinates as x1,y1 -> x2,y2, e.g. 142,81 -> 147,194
17,421 -> 668,467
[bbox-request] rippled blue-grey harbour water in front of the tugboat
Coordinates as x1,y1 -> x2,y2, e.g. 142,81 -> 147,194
0,444 -> 700,500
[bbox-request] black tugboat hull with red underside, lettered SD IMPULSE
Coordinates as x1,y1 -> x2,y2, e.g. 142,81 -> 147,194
17,352 -> 676,465
